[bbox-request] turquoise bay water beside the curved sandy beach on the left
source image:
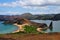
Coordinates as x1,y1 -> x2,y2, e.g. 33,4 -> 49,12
0,22 -> 18,34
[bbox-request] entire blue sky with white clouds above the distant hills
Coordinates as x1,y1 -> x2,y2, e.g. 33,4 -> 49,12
0,0 -> 60,15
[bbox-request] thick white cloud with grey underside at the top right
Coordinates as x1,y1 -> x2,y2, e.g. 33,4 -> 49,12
23,0 -> 60,7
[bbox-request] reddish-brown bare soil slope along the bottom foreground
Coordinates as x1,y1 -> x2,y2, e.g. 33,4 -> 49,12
0,33 -> 60,40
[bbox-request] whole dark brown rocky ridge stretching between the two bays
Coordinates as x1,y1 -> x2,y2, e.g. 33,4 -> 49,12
4,18 -> 47,28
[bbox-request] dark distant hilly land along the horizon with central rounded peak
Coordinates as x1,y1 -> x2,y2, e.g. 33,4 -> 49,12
0,13 -> 60,21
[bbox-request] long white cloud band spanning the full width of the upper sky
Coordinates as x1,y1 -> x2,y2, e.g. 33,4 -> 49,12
0,0 -> 60,7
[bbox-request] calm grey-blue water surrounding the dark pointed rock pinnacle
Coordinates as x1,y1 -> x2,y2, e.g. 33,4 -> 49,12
31,20 -> 60,32
